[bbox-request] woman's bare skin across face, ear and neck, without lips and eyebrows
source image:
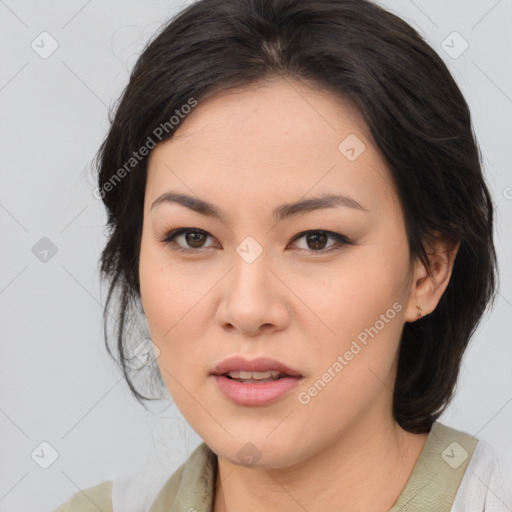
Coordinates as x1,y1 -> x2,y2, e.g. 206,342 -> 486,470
139,79 -> 456,512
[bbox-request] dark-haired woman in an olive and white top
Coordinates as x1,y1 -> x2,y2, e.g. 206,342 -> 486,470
54,0 -> 512,512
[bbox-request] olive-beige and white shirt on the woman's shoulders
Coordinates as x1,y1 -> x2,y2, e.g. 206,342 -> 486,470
55,422 -> 512,512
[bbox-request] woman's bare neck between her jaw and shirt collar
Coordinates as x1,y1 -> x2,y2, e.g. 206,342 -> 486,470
213,418 -> 428,512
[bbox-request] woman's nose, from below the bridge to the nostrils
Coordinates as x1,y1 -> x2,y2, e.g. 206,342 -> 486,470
216,253 -> 290,337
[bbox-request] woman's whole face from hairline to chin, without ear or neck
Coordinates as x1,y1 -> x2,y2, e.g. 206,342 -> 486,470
139,81 -> 420,468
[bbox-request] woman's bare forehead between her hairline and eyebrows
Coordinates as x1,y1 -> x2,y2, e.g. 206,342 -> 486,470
147,80 -> 393,216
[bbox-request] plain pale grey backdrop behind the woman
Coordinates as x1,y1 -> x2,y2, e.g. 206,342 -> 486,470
0,0 -> 512,512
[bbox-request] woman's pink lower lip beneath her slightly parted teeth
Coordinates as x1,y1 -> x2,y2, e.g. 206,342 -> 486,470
213,375 -> 301,405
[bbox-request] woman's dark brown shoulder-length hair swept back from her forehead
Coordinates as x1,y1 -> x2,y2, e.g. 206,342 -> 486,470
92,0 -> 497,433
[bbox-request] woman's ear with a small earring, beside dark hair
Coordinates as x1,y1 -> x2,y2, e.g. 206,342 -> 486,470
405,235 -> 460,322
